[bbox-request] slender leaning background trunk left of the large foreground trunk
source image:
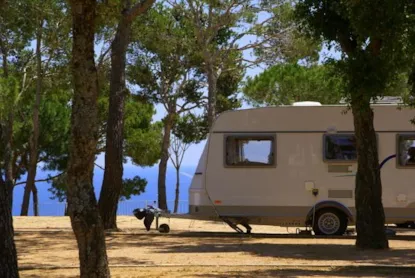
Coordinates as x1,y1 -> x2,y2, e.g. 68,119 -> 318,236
20,19 -> 43,216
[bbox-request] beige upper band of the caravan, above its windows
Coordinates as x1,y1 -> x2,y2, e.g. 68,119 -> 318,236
212,104 -> 415,133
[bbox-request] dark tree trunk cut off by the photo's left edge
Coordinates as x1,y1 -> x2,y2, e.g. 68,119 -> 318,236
0,35 -> 19,278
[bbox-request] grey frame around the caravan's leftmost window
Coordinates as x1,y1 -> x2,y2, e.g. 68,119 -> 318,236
223,132 -> 277,169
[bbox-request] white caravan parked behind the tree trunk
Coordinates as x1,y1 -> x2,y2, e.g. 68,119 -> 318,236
189,102 -> 415,235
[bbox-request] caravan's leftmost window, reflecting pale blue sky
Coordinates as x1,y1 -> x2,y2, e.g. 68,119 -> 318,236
225,135 -> 275,167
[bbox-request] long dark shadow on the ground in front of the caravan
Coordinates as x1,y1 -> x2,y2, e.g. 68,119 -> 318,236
154,240 -> 415,266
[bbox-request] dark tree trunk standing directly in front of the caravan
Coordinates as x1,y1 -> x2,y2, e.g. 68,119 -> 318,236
351,96 -> 389,249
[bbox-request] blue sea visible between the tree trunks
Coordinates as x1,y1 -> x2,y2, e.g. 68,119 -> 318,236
13,165 -> 196,216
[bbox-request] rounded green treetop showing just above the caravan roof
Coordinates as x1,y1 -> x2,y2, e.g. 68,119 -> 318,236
243,63 -> 344,106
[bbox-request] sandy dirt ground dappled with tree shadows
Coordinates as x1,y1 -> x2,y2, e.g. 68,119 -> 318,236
14,216 -> 415,277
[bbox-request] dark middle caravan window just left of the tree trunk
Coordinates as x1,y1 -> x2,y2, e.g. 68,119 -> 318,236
324,134 -> 357,161
